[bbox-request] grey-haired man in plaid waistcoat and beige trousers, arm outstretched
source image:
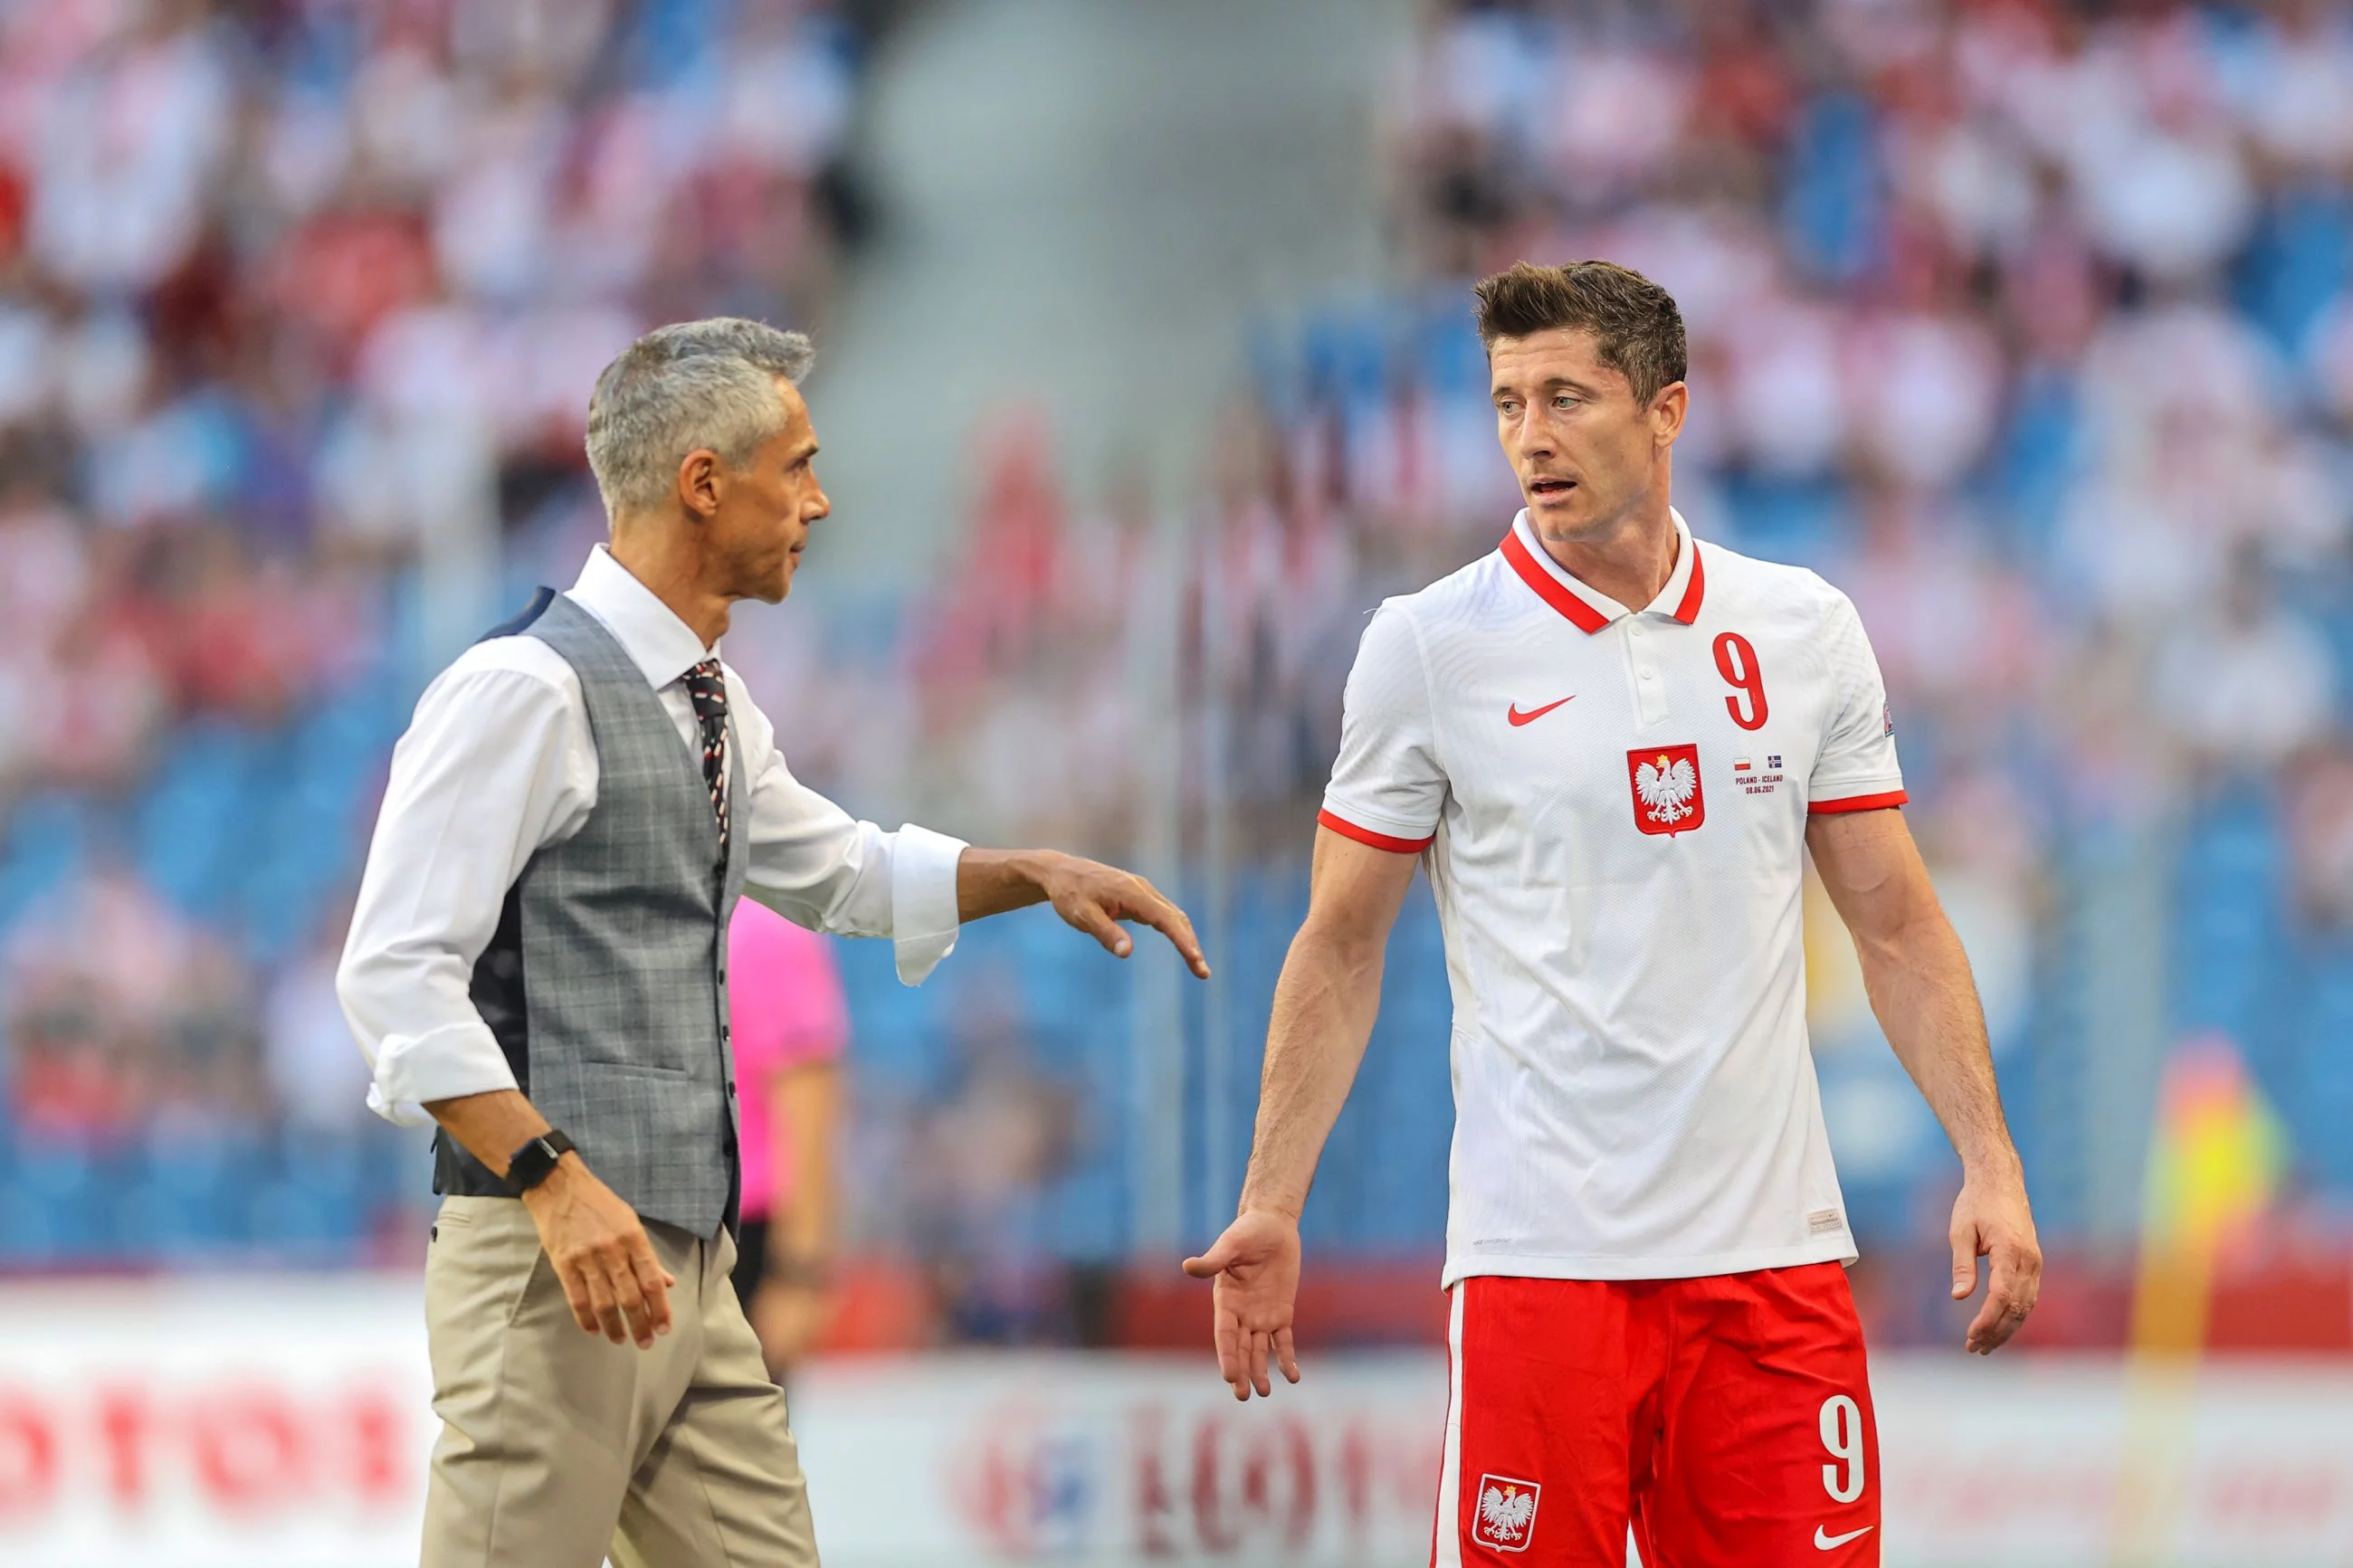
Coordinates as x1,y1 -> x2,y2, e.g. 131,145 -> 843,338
337,319 -> 1207,1568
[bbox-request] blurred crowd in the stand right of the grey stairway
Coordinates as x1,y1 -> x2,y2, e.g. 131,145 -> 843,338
795,0 -> 2353,1239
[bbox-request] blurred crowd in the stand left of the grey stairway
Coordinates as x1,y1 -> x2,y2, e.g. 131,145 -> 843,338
0,0 -> 871,1222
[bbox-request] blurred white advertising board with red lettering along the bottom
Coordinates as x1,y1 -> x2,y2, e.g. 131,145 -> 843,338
0,1274 -> 2353,1568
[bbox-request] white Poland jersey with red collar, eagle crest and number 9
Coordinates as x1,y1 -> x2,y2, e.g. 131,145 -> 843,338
1320,512 -> 1903,1286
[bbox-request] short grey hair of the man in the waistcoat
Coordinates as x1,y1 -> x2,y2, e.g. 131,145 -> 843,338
588,315 -> 816,518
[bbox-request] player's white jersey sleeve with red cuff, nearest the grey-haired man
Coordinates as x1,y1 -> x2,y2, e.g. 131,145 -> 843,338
1315,604 -> 1447,856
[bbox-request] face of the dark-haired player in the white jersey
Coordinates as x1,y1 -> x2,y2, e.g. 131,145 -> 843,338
1487,327 -> 1685,543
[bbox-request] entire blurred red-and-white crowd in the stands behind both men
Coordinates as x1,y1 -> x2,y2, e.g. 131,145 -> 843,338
0,0 -> 2353,1337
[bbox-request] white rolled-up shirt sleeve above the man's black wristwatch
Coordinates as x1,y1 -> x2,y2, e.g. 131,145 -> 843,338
334,644 -> 595,1126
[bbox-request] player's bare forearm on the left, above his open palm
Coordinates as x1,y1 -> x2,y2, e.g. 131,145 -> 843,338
1240,927 -> 1384,1220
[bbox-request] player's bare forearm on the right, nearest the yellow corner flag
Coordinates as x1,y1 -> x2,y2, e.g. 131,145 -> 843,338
1859,908 -> 2019,1175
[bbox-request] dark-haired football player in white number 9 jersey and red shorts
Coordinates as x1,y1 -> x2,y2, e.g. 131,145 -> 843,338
1186,261 -> 2043,1568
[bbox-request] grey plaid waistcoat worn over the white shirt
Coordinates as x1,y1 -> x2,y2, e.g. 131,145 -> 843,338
433,590 -> 750,1237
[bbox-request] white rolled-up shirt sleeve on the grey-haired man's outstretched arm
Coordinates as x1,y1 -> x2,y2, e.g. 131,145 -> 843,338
729,681 -> 967,985
